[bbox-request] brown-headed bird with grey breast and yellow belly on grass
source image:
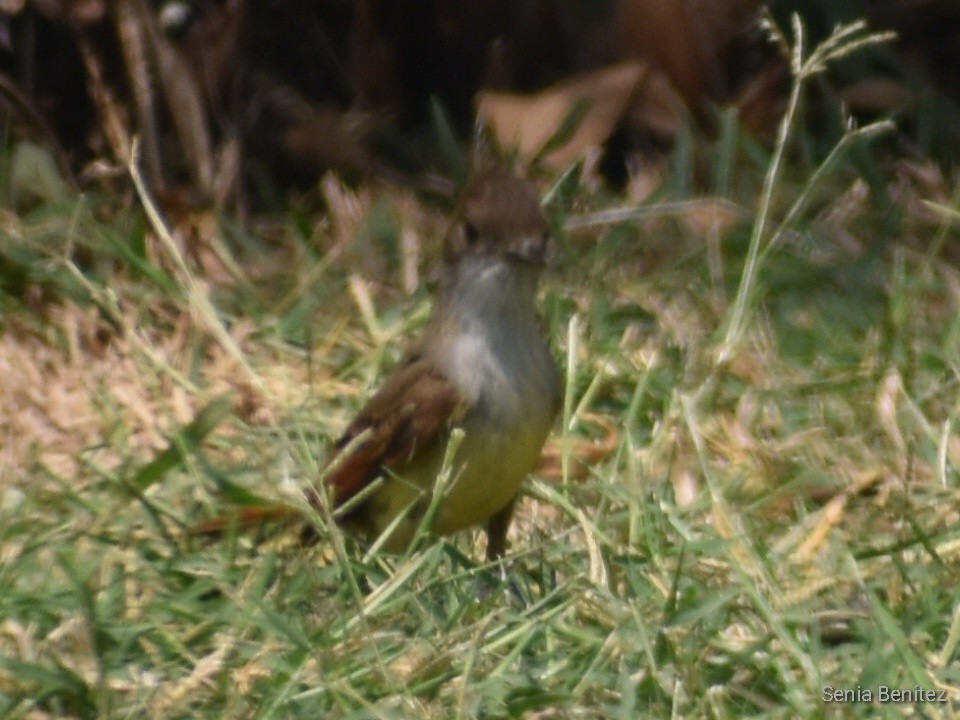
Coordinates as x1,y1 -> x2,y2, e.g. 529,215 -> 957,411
200,166 -> 562,560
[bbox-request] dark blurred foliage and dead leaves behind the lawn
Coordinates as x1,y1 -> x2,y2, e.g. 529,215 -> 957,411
0,0 -> 960,211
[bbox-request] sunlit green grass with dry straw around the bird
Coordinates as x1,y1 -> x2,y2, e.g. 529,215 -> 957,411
0,16 -> 960,719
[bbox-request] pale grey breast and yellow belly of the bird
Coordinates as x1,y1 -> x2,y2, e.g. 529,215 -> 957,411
346,296 -> 560,550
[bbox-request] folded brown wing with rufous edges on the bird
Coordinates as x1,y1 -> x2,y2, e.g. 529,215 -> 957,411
326,359 -> 464,504
